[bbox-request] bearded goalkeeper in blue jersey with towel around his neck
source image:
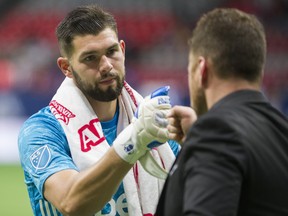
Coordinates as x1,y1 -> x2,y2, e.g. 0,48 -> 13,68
18,5 -> 179,216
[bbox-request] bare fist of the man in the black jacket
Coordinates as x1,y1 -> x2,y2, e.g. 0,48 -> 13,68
167,106 -> 197,144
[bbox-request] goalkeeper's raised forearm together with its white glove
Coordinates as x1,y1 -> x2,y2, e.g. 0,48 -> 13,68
44,88 -> 171,216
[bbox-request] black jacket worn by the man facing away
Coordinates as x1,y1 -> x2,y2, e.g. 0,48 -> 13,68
156,90 -> 288,216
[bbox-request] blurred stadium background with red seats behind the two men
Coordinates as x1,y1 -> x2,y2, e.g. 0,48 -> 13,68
0,0 -> 288,216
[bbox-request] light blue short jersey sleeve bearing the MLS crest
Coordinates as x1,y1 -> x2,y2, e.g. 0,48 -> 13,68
18,107 -> 78,197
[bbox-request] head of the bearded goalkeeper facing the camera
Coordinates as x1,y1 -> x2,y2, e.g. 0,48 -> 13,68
56,5 -> 126,103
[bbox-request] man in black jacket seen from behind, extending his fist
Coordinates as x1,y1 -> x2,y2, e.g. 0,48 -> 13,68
156,8 -> 288,216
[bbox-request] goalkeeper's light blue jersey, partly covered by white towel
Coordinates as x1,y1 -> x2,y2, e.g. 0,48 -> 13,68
18,107 -> 179,216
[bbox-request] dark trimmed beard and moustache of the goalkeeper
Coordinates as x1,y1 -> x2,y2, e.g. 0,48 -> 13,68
72,68 -> 125,102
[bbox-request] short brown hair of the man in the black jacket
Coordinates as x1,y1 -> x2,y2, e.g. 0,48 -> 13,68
189,8 -> 266,82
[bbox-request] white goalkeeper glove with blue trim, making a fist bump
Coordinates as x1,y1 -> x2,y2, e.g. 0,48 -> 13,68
113,86 -> 171,167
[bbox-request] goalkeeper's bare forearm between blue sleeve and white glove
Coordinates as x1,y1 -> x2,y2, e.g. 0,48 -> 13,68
44,148 -> 132,216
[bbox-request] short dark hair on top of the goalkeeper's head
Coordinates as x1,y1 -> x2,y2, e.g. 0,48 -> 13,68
56,5 -> 118,57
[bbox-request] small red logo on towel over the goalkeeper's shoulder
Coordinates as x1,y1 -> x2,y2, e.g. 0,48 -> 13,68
49,100 -> 76,125
